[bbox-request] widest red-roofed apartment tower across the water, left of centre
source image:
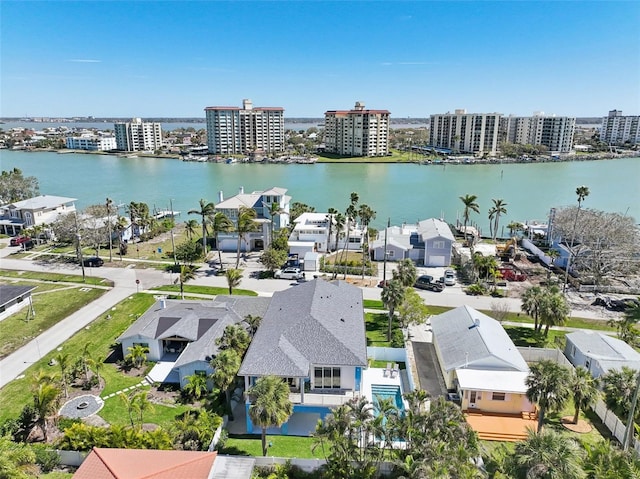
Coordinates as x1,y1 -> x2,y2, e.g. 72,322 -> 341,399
204,100 -> 285,155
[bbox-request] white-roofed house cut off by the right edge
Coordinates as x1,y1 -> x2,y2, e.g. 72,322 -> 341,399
564,331 -> 640,378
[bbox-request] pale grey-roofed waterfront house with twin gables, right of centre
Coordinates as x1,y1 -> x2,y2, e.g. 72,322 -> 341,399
371,218 -> 455,266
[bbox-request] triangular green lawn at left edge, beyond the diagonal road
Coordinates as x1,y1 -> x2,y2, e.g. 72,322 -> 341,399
0,281 -> 107,358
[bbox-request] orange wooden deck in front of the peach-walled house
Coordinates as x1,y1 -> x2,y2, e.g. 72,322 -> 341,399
464,410 -> 538,442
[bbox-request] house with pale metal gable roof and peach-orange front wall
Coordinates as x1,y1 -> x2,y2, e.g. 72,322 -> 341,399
431,306 -> 534,414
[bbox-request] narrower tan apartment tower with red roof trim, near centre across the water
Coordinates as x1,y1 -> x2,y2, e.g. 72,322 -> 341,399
324,101 -> 390,156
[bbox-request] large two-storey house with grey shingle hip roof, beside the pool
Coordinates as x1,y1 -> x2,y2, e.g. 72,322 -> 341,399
238,279 -> 367,434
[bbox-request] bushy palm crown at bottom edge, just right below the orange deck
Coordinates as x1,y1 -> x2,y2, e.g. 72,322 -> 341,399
512,430 -> 586,479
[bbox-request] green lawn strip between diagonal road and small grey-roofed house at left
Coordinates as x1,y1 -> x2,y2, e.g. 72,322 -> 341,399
0,294 -> 155,422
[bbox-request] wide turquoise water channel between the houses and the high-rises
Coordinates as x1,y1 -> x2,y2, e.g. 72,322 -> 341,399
0,150 -> 640,234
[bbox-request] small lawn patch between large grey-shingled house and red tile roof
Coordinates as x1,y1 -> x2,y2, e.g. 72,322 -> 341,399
220,434 -> 324,459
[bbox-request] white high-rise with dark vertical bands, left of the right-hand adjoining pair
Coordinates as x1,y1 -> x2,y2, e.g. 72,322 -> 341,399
429,110 -> 502,156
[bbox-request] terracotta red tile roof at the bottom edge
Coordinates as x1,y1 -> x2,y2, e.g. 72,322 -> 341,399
73,447 -> 217,479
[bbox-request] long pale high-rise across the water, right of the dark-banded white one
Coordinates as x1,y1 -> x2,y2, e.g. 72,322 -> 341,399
500,112 -> 576,153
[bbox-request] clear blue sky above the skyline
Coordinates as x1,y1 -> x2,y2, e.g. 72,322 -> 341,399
0,0 -> 640,117
